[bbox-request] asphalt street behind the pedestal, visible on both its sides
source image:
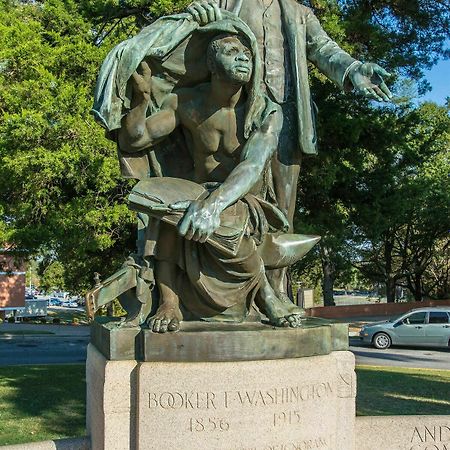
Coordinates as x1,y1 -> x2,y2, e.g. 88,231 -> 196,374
0,330 -> 450,370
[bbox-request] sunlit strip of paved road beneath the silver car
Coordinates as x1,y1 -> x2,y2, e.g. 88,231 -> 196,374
350,338 -> 450,370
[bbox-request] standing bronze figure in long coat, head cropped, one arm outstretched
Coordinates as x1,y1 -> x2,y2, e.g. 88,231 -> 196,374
188,0 -> 391,304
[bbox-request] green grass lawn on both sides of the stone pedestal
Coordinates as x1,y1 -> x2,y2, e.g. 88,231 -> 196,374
0,364 -> 450,445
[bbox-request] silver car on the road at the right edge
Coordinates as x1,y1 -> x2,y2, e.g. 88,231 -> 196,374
359,307 -> 450,349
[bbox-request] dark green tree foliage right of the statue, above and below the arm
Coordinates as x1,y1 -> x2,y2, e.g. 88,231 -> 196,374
295,0 -> 450,304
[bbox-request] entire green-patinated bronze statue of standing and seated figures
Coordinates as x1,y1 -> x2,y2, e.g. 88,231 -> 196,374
87,4 -> 390,332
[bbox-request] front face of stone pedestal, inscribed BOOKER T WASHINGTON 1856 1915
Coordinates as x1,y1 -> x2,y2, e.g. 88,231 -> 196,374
137,352 -> 355,450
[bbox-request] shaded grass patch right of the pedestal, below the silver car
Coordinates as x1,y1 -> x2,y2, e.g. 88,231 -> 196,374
356,367 -> 450,416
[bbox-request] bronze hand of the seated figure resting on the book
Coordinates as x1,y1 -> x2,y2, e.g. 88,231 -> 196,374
170,199 -> 222,242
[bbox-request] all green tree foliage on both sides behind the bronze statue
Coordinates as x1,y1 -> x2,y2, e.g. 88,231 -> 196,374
0,0 -> 450,301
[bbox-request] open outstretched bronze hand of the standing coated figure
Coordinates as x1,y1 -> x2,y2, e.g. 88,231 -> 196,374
348,63 -> 392,102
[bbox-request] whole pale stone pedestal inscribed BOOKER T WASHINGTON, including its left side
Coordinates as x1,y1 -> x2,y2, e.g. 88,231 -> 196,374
87,322 -> 356,450
